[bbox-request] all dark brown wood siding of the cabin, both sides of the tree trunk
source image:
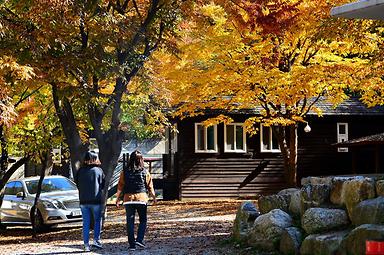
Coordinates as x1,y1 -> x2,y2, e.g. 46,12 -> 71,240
176,115 -> 384,199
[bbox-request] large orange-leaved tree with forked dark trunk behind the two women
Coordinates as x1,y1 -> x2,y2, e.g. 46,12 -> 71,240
0,0 -> 185,209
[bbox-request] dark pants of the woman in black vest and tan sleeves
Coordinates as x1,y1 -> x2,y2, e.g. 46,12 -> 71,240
125,204 -> 147,247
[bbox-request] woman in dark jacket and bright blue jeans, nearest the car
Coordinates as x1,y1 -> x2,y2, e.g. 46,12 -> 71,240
75,151 -> 104,251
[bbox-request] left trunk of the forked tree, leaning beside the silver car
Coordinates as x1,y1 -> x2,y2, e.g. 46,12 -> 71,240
52,84 -> 88,179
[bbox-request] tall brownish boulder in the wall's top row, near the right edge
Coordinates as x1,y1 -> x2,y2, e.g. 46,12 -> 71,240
342,177 -> 376,217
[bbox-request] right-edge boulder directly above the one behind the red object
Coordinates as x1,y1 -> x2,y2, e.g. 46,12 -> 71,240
351,197 -> 384,226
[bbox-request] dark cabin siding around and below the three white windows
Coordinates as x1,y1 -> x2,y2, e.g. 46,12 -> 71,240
177,116 -> 285,199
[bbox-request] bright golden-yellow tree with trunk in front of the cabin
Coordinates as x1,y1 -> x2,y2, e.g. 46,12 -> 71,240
154,0 -> 378,186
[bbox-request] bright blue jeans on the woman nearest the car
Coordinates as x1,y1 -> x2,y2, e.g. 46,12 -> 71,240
80,204 -> 101,245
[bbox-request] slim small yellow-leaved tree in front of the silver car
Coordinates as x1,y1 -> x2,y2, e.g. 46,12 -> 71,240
9,85 -> 63,236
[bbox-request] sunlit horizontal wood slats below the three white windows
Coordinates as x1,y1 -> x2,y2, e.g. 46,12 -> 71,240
181,158 -> 284,199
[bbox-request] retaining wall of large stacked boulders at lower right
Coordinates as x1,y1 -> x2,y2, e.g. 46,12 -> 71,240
233,176 -> 384,255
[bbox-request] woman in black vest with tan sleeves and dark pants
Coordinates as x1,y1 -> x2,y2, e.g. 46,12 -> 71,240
116,150 -> 156,250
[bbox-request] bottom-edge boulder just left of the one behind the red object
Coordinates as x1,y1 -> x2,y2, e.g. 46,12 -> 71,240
300,230 -> 352,255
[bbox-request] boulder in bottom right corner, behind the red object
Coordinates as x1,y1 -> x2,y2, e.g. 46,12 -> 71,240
338,224 -> 384,255
